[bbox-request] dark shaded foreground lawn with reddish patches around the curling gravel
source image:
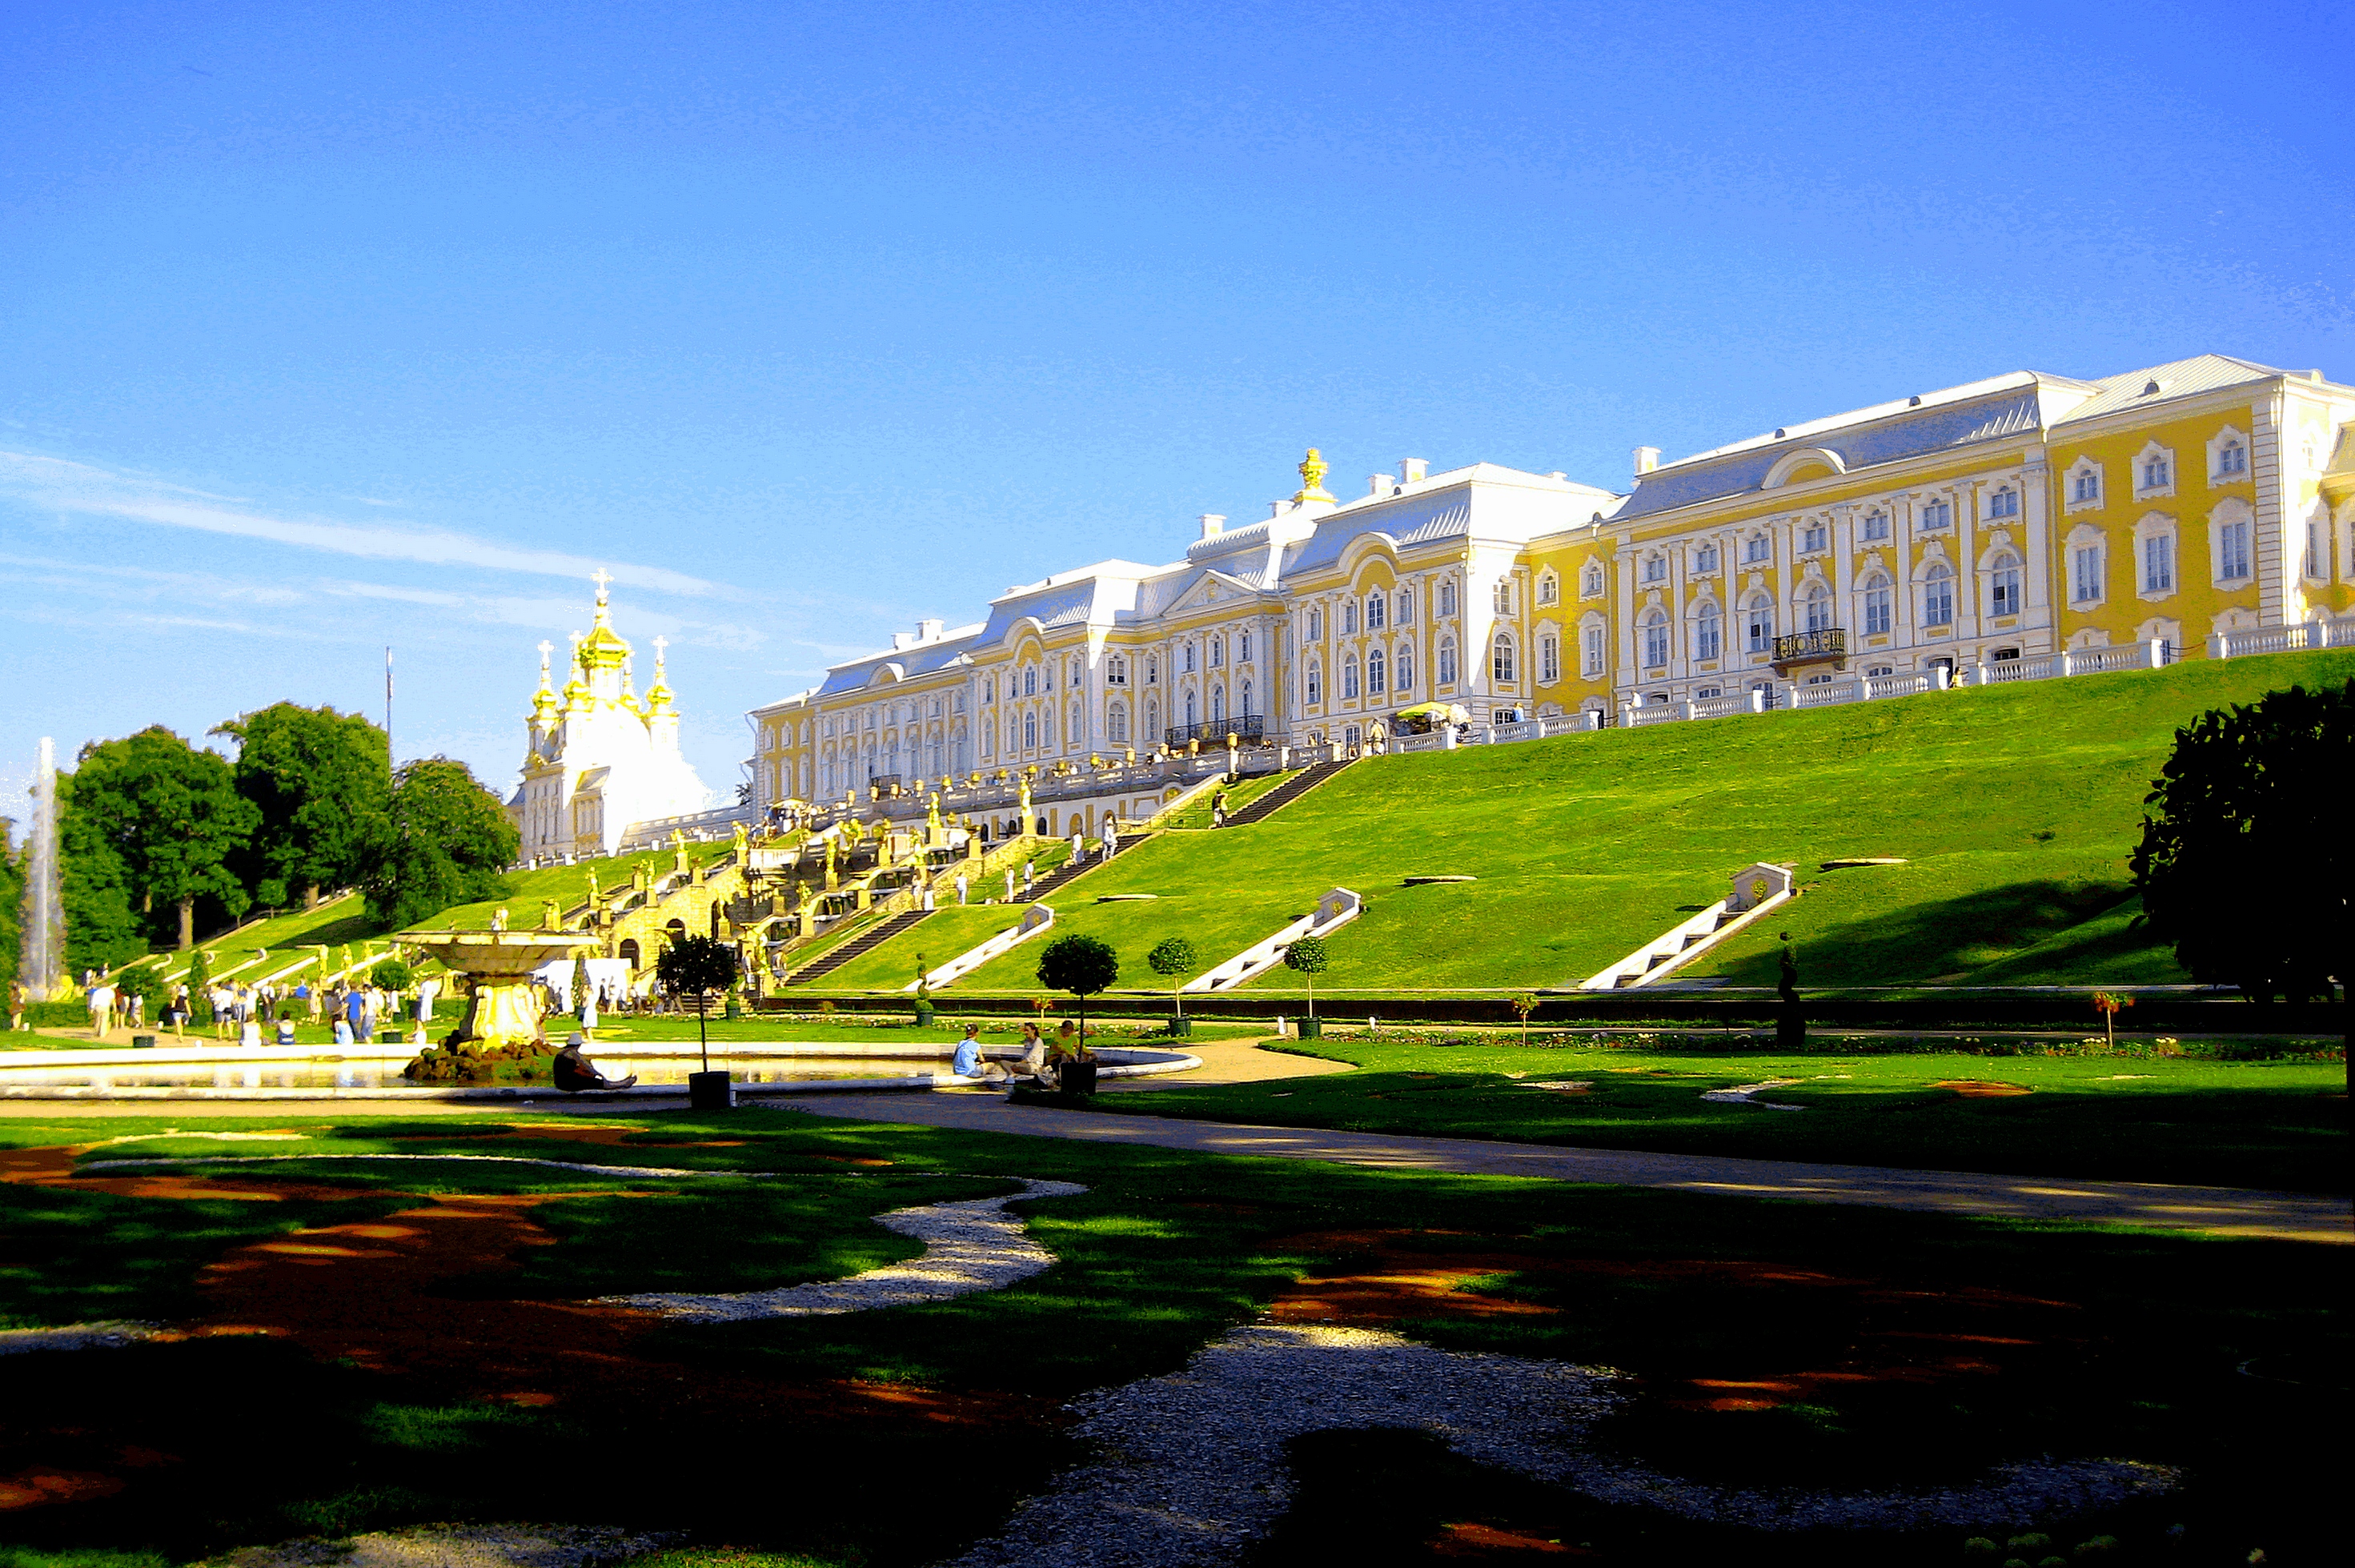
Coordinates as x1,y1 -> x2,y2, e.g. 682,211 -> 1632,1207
0,1111 -> 2348,1568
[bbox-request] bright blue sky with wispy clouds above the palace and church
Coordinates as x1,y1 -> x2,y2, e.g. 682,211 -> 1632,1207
0,0 -> 2355,810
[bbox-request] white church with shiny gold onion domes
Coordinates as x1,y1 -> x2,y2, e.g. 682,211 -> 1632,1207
507,572 -> 711,860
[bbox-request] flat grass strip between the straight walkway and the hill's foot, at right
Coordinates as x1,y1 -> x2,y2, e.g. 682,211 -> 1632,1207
1097,1036 -> 2350,1191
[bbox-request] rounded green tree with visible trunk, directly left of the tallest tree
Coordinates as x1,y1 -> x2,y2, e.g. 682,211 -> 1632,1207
73,725 -> 262,946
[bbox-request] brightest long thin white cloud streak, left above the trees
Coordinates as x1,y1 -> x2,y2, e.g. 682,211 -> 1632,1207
0,452 -> 735,598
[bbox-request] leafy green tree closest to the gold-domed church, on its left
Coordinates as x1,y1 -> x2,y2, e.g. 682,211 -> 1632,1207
358,756 -> 518,928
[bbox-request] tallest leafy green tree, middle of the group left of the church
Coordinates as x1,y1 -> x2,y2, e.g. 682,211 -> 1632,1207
215,702 -> 393,906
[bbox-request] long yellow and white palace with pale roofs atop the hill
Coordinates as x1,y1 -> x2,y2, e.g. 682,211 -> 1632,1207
749,355 -> 2355,831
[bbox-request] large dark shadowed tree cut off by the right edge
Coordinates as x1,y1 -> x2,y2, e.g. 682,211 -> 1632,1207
2129,683 -> 2355,1003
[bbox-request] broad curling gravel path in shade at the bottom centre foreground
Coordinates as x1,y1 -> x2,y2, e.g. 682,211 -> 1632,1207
956,1323 -> 2176,1568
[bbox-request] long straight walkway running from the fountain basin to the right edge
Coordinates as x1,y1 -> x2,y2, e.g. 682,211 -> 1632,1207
784,1095 -> 2355,1243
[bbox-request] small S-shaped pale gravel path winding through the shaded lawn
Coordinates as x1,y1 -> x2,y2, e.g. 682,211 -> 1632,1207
596,1180 -> 1088,1323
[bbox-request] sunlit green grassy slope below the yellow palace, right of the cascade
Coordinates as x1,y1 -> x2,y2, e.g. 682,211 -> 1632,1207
812,652 -> 2355,993
